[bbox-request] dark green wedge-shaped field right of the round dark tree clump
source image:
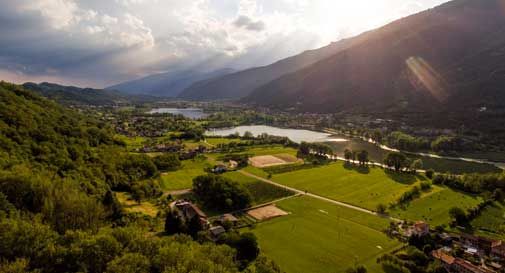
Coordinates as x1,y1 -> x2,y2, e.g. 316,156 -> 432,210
223,172 -> 294,205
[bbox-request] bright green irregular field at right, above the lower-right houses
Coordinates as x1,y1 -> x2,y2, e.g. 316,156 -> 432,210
391,186 -> 482,226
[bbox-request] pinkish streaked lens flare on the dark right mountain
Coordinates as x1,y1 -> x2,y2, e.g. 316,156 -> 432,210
405,57 -> 449,102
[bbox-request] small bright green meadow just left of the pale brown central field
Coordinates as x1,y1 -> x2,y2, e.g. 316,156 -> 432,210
161,159 -> 209,191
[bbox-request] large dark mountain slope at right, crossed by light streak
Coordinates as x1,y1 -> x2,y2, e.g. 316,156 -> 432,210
246,0 -> 505,112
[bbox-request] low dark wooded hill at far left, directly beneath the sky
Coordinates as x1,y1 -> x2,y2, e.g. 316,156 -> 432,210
23,82 -> 156,105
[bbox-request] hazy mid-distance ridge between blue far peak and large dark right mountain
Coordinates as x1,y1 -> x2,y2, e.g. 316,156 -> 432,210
179,38 -> 366,100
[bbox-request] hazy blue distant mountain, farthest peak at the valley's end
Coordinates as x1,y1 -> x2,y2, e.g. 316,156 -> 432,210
106,68 -> 234,97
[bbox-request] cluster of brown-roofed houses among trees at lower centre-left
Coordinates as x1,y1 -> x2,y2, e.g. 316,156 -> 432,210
170,200 -> 239,241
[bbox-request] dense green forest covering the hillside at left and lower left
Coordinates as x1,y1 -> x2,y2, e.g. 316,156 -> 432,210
0,82 -> 278,272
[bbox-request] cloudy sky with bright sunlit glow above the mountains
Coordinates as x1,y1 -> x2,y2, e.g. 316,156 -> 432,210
0,0 -> 447,88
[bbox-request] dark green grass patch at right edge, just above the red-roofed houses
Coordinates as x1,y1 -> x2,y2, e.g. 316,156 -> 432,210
471,203 -> 505,240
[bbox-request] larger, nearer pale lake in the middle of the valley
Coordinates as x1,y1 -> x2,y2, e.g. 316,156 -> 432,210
206,125 -> 347,143
